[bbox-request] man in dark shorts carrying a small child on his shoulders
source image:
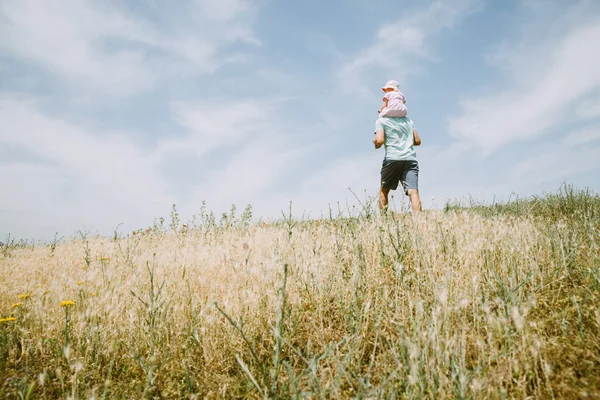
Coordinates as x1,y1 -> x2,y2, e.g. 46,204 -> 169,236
373,117 -> 421,213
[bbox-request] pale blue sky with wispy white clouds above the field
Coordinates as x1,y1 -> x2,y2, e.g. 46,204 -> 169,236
0,0 -> 600,241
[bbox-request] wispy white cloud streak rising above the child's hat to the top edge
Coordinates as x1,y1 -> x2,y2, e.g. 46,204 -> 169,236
340,0 -> 481,92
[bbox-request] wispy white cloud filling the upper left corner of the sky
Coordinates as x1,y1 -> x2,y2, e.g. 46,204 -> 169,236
0,0 -> 257,95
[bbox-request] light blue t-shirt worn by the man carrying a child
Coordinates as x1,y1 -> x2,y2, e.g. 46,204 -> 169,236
375,117 -> 417,160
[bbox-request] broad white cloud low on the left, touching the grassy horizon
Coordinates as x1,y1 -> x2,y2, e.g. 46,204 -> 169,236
0,100 -> 173,237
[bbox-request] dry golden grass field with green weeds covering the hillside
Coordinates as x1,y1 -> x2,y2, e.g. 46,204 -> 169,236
0,186 -> 600,399
